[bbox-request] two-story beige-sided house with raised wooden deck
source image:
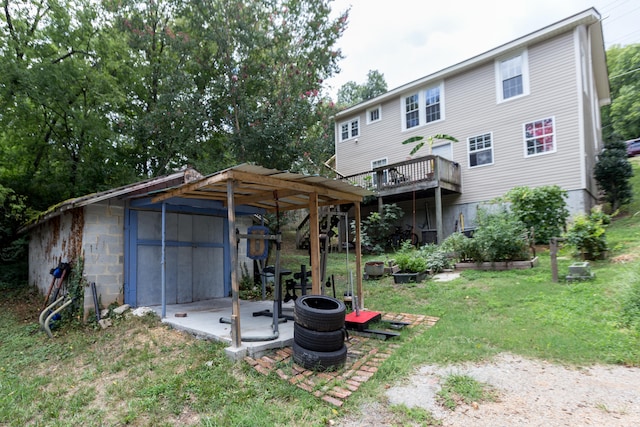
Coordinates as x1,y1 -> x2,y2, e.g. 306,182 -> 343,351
335,8 -> 610,241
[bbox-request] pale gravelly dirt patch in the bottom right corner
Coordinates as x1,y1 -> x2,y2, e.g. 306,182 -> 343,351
340,354 -> 640,427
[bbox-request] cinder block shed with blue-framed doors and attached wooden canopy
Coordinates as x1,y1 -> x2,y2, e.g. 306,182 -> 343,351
23,164 -> 371,346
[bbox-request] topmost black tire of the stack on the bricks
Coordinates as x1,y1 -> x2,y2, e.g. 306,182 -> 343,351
293,295 -> 347,332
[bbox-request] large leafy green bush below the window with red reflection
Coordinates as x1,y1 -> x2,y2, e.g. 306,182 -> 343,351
503,185 -> 569,243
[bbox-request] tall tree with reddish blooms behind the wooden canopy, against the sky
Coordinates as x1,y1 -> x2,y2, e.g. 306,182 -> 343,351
179,0 -> 347,169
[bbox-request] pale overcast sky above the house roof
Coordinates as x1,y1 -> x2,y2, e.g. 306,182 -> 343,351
328,0 -> 640,99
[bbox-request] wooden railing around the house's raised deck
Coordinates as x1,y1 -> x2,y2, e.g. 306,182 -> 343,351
343,155 -> 461,193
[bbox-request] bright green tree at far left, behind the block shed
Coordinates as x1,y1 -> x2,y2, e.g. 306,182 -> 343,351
0,0 -> 131,209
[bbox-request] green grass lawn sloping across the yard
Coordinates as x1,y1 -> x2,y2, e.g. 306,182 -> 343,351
0,159 -> 640,426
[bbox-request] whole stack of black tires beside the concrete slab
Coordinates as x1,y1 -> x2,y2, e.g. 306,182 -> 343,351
293,295 -> 348,371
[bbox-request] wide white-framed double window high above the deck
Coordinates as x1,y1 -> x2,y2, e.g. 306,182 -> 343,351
402,84 -> 443,130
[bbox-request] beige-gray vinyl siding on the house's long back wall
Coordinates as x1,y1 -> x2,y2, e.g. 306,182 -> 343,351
336,32 -> 591,203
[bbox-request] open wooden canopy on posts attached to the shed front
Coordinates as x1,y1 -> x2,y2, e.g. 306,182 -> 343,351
152,164 -> 373,347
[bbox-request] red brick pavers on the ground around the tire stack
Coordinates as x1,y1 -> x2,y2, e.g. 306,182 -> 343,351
244,313 -> 439,406
